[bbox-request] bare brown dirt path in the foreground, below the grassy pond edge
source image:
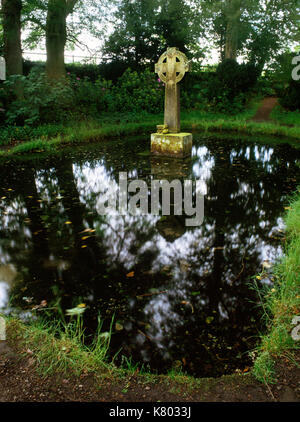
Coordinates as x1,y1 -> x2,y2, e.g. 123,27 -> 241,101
0,342 -> 300,402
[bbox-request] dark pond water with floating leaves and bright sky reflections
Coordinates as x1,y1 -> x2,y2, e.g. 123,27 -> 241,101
0,135 -> 300,376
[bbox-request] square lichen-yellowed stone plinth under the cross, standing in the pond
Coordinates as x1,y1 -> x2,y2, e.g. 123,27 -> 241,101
151,133 -> 193,158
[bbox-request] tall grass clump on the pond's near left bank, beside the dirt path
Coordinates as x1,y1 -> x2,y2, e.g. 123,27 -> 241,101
7,316 -> 113,376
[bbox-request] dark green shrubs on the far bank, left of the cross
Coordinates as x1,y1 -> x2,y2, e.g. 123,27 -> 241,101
0,68 -> 164,123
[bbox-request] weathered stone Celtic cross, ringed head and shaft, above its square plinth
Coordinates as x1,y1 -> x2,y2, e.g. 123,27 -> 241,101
155,47 -> 191,133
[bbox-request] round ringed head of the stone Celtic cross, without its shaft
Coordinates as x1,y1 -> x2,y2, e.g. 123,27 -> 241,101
155,47 -> 191,83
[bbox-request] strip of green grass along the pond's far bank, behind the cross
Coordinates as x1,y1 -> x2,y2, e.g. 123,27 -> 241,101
0,102 -> 300,157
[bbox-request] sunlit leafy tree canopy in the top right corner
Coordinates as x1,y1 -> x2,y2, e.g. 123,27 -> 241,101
195,0 -> 299,70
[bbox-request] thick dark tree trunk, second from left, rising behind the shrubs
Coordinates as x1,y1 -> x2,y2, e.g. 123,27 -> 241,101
46,0 -> 67,79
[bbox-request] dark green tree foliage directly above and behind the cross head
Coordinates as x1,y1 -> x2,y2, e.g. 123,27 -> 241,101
104,0 -> 198,69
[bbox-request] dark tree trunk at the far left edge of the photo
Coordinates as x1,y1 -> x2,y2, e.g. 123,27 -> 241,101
2,0 -> 23,76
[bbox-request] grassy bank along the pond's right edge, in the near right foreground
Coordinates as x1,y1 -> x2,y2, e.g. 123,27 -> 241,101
253,187 -> 300,383
